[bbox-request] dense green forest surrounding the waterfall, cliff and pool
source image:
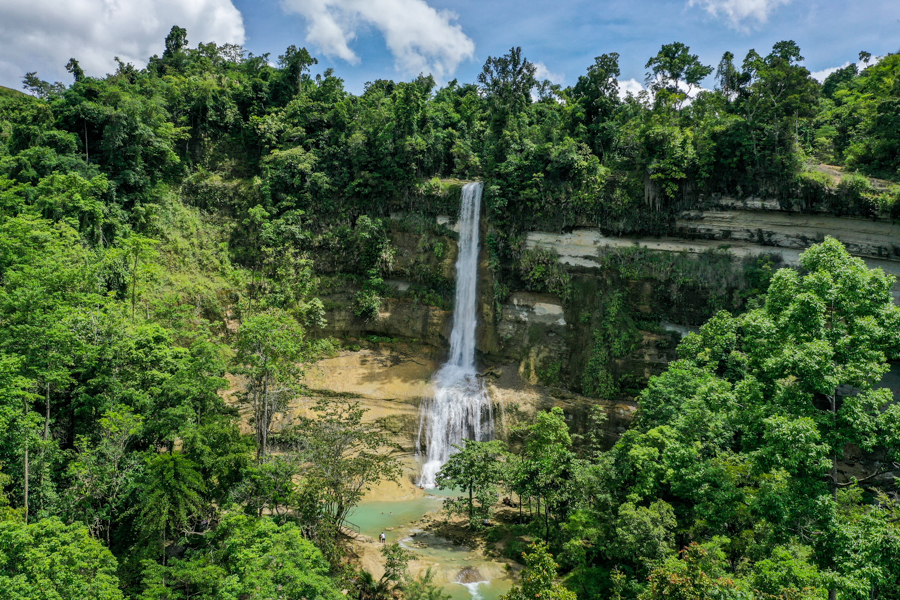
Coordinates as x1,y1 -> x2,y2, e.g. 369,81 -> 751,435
0,27 -> 900,600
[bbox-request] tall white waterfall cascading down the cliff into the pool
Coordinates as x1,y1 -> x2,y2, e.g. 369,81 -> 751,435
416,183 -> 494,488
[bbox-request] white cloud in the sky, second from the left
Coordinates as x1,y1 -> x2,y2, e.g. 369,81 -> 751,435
282,0 -> 475,79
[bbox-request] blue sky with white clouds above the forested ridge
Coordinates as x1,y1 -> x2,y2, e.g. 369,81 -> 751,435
0,0 -> 900,92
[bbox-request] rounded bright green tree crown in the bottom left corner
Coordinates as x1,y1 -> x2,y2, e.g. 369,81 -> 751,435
0,517 -> 124,600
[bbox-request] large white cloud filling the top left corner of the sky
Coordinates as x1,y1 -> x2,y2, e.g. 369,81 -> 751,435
0,0 -> 244,89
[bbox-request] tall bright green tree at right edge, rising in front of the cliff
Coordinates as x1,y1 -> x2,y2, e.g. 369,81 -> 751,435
751,237 -> 900,492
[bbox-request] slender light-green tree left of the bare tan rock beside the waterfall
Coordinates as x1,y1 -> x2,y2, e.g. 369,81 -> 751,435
235,309 -> 310,462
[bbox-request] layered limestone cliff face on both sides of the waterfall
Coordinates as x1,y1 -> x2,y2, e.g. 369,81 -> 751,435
310,203 -> 900,452
